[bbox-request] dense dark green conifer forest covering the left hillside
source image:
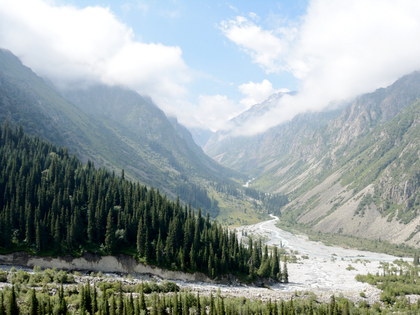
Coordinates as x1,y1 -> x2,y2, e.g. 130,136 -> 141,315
0,123 -> 288,282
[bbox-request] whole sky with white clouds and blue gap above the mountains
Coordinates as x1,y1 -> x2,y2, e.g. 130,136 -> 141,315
0,0 -> 420,135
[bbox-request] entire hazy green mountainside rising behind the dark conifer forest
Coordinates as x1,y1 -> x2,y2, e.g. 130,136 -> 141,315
0,50 -> 249,215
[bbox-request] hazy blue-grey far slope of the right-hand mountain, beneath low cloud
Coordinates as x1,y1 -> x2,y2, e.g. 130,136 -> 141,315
204,108 -> 337,178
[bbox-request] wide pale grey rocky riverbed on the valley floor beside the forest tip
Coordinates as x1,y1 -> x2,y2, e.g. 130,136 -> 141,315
230,216 -> 410,302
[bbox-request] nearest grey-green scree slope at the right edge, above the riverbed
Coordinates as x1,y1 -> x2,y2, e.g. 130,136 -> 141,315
285,102 -> 420,246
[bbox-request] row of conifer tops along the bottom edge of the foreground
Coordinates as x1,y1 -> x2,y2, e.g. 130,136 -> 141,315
0,283 -> 420,315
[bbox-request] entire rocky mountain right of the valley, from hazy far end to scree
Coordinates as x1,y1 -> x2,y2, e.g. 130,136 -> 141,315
205,72 -> 420,246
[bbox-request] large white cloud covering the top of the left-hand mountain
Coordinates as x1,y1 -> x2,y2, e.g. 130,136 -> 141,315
0,0 -> 190,108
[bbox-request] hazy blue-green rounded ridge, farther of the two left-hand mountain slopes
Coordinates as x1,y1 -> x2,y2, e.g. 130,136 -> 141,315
63,85 -> 237,185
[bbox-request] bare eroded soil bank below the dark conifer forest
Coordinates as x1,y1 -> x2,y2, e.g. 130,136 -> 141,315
0,252 -> 211,282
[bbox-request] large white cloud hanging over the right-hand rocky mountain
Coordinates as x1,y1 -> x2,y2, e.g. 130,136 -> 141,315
221,0 -> 420,135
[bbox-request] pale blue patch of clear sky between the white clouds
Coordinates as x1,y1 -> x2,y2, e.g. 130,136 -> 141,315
60,0 -> 307,102
